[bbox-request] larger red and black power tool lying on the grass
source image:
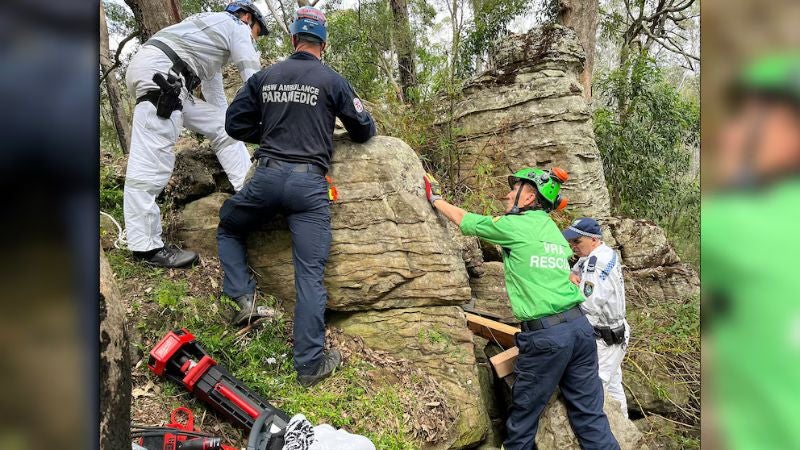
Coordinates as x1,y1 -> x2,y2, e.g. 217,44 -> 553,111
147,328 -> 289,433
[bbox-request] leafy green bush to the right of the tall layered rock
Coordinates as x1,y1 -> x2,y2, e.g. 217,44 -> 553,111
594,56 -> 700,263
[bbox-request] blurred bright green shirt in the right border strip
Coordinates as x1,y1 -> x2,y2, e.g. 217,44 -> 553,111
701,179 -> 800,450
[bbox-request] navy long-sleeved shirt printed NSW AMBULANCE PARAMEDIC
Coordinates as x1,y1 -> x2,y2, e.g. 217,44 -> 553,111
225,52 -> 375,171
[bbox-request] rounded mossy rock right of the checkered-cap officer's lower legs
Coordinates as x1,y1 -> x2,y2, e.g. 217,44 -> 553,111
622,352 -> 689,415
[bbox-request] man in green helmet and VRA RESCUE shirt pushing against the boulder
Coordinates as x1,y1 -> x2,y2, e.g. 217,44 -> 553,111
425,168 -> 619,450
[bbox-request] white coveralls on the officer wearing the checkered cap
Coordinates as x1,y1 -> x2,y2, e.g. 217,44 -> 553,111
572,243 -> 630,417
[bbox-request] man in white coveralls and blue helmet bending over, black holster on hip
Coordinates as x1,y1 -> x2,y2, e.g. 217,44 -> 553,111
124,0 -> 267,267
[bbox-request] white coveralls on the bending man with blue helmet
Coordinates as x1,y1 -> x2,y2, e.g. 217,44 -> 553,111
123,12 -> 261,252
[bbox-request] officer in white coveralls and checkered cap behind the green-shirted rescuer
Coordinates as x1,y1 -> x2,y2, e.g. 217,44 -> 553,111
562,217 -> 630,417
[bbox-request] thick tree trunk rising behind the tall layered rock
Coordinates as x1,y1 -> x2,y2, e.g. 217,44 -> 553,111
558,0 -> 599,102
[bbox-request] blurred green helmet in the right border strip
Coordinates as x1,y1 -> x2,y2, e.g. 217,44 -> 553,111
737,52 -> 800,102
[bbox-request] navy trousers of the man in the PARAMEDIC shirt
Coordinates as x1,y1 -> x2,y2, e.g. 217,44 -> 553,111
217,164 -> 331,375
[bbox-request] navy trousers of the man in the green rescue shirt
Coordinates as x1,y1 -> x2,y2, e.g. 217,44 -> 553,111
503,316 -> 619,450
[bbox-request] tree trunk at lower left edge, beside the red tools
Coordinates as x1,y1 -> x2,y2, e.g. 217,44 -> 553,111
99,249 -> 131,450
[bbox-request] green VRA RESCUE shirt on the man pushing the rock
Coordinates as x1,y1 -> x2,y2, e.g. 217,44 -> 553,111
461,210 -> 584,320
